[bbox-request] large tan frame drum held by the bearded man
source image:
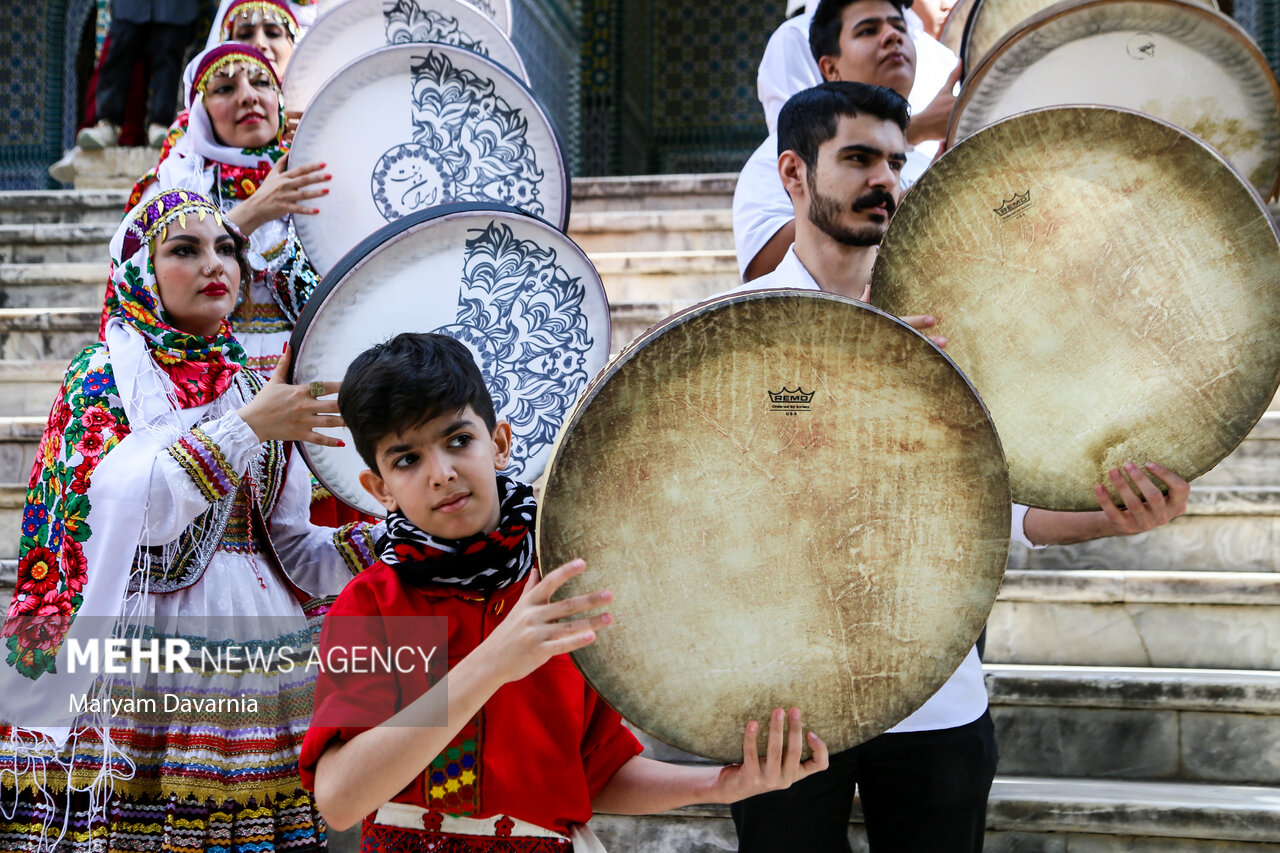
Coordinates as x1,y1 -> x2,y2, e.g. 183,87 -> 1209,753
872,106 -> 1280,510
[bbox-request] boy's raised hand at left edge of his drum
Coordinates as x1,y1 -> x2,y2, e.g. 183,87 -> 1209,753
472,560 -> 613,684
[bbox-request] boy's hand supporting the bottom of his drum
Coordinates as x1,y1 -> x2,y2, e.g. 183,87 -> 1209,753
716,708 -> 829,803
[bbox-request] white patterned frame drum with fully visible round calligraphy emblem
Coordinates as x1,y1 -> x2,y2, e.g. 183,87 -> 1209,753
289,45 -> 570,274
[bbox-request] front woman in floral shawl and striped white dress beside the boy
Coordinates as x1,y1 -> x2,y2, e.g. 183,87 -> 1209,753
0,191 -> 374,852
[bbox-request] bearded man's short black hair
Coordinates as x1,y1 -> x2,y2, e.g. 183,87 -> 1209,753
778,81 -> 911,169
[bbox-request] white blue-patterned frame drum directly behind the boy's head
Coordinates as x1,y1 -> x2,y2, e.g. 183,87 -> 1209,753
291,204 -> 609,515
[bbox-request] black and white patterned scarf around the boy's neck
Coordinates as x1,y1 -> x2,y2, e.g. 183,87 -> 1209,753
378,476 -> 538,593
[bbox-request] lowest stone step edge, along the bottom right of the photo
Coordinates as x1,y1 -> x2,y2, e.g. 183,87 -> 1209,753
634,776 -> 1280,841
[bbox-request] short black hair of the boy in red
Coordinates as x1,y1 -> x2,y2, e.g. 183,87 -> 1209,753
338,332 -> 498,474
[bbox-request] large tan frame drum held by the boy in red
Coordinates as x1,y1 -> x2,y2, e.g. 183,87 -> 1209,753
538,291 -> 1010,762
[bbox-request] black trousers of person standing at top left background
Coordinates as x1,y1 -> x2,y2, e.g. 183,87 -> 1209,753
97,20 -> 191,127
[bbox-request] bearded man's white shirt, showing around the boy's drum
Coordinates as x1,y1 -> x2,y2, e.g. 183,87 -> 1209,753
728,246 -> 1037,734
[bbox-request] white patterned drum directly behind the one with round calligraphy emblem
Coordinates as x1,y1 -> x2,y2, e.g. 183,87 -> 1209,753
282,0 -> 529,110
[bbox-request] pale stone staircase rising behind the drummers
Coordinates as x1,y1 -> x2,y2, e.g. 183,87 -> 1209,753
0,175 -> 1280,853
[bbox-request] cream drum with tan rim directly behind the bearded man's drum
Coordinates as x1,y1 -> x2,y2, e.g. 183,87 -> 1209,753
947,0 -> 1280,197
